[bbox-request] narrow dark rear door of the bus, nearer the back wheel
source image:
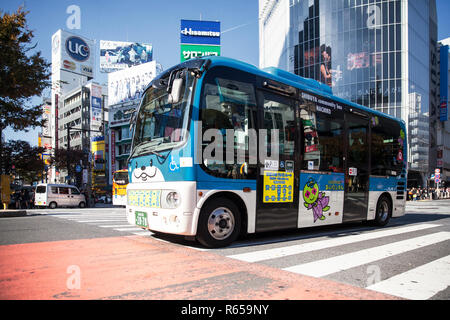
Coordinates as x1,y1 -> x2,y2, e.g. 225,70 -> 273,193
343,112 -> 370,222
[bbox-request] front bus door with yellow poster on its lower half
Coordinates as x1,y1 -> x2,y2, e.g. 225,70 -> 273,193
256,90 -> 300,232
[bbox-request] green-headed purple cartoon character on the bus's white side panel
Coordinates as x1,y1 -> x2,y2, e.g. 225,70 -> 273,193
303,178 -> 330,222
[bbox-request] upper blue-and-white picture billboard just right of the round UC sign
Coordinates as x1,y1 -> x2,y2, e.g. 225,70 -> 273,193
100,40 -> 153,72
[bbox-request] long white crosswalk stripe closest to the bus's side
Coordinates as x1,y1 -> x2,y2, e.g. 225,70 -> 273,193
228,224 -> 440,262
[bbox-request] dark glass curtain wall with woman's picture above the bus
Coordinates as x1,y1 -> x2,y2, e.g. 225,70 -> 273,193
289,0 -> 402,118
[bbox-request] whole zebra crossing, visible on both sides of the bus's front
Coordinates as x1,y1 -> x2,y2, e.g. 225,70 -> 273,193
43,208 -> 450,300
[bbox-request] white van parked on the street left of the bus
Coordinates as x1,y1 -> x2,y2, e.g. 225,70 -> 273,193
34,183 -> 86,209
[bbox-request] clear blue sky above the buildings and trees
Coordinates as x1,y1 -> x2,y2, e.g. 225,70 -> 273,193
0,0 -> 450,145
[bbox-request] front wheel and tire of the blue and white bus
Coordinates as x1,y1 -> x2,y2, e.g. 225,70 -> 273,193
196,198 -> 241,248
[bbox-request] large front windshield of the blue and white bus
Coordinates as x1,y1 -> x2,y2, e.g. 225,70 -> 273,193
131,72 -> 194,156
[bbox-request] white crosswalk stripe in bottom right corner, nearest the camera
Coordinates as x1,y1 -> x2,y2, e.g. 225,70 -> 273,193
366,256 -> 450,300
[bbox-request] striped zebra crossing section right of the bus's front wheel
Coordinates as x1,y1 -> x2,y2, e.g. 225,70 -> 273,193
224,223 -> 450,300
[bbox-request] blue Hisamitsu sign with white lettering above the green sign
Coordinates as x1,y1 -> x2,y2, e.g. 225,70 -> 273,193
180,20 -> 220,46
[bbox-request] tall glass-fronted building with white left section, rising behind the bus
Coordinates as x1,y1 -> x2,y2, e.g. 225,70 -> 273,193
259,0 -> 438,186
